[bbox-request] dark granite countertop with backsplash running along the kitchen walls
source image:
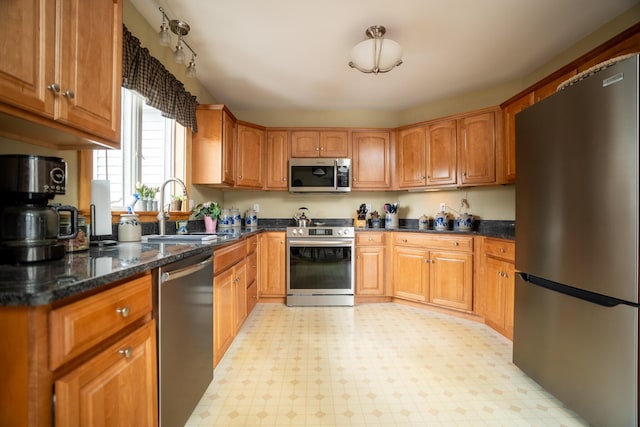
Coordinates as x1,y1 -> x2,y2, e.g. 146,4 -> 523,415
0,219 -> 515,306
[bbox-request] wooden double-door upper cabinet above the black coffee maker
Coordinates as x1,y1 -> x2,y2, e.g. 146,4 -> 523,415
0,0 -> 122,148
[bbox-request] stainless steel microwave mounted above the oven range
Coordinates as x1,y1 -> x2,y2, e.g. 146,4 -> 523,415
289,158 -> 351,193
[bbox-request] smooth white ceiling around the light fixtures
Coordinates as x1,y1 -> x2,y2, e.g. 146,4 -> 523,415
131,0 -> 638,110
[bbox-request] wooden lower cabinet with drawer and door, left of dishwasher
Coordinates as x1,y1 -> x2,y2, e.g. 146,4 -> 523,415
0,271 -> 158,427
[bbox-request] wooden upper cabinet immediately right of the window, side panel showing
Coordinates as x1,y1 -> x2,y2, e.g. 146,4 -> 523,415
191,104 -> 236,185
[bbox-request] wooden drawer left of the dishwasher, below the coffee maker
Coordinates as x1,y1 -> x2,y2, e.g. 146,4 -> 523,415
49,275 -> 152,370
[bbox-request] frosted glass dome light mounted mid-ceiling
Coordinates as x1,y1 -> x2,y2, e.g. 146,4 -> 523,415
349,25 -> 402,74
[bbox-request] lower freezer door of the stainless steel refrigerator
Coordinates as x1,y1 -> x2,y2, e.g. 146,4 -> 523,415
513,276 -> 638,426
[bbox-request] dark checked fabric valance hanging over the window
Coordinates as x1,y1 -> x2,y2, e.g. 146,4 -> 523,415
122,25 -> 198,132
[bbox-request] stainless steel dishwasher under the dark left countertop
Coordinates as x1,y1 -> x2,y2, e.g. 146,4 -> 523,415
155,252 -> 213,427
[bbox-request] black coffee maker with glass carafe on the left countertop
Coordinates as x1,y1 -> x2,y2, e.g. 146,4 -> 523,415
0,154 -> 78,264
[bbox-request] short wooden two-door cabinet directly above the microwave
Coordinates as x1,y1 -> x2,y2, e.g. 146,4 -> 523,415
291,130 -> 349,158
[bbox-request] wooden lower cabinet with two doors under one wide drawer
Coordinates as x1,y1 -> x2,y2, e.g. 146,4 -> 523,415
393,233 -> 473,312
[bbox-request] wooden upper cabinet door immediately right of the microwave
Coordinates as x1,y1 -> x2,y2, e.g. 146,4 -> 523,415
351,132 -> 391,190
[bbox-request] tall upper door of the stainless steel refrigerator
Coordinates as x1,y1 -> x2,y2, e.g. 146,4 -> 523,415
516,56 -> 638,303
